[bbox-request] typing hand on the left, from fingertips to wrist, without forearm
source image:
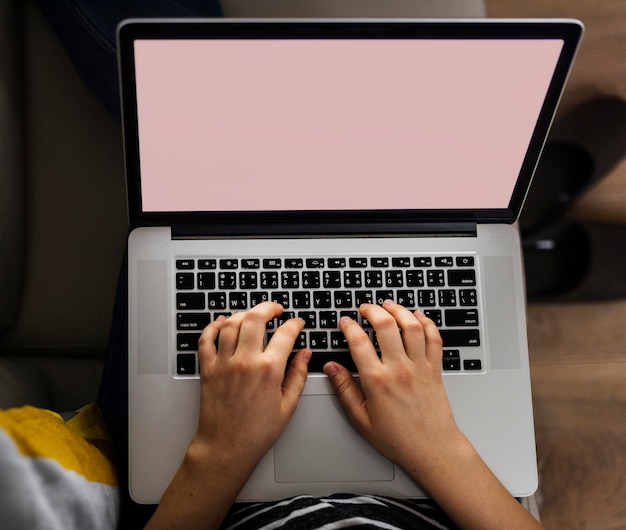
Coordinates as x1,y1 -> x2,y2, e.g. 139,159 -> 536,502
192,302 -> 311,474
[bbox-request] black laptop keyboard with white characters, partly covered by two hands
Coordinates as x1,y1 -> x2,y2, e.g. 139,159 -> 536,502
174,254 -> 485,377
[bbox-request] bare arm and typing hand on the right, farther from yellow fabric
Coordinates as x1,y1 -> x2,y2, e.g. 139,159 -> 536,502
324,301 -> 541,530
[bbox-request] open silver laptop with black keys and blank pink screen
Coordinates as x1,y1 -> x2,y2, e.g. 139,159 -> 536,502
118,19 -> 582,503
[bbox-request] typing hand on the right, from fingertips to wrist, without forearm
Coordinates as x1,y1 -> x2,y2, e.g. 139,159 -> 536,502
324,300 -> 464,478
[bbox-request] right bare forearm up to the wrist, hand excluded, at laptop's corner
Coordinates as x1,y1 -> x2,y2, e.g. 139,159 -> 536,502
405,434 -> 542,530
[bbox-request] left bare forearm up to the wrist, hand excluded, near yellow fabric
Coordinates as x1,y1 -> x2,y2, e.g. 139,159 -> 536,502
146,444 -> 253,530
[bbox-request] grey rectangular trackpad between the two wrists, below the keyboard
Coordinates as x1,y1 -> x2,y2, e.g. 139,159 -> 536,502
274,395 -> 394,482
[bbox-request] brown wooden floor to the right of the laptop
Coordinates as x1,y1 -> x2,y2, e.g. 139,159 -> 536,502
486,0 -> 626,530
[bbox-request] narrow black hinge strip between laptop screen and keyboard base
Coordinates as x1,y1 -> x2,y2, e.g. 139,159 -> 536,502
172,222 -> 476,239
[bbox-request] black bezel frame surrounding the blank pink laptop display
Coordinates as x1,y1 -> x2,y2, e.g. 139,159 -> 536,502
118,19 -> 583,228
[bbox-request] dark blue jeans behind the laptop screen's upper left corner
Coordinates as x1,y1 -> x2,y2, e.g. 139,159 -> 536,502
35,0 -> 222,118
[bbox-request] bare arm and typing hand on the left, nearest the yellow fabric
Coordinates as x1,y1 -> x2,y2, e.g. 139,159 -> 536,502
146,302 -> 311,529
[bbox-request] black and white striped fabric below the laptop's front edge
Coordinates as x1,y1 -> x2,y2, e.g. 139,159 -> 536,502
223,494 -> 457,530
